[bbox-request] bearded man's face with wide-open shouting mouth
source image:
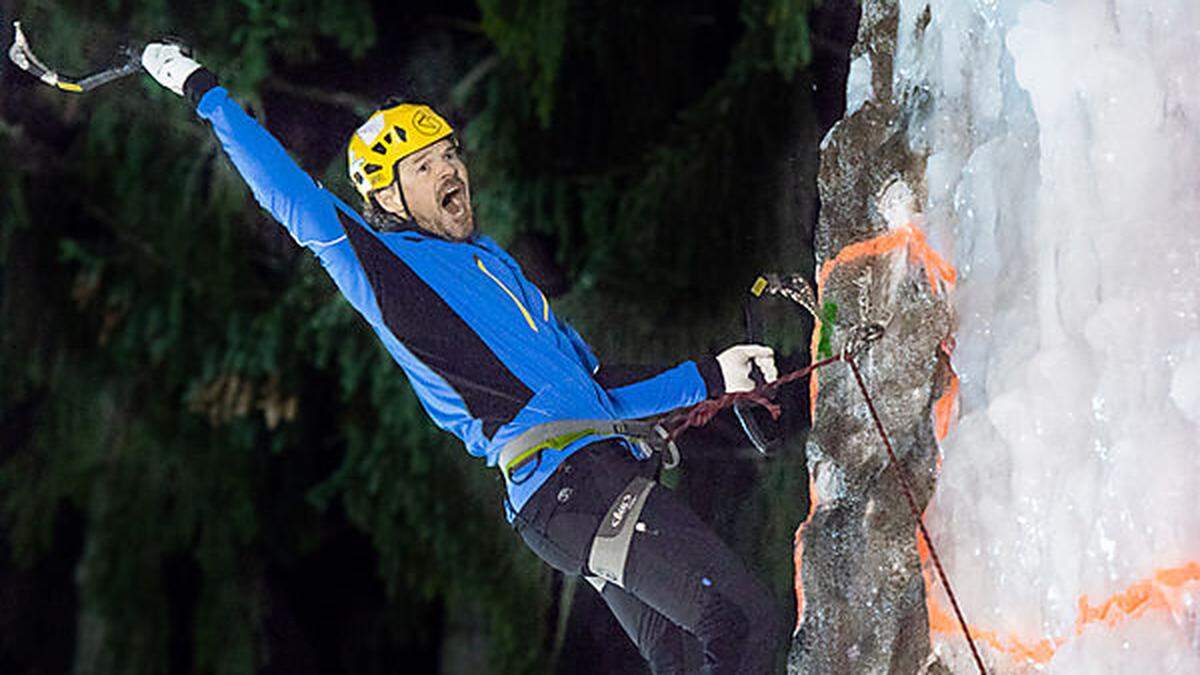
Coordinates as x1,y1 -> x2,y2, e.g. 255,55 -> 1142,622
374,138 -> 475,241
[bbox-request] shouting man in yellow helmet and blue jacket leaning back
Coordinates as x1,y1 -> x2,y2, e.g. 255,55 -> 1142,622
142,43 -> 784,675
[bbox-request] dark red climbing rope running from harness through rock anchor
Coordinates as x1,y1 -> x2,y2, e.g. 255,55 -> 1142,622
662,354 -> 988,675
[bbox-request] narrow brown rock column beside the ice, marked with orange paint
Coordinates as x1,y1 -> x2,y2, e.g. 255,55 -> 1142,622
788,0 -> 954,674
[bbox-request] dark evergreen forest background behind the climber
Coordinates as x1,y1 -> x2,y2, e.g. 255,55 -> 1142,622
0,0 -> 858,675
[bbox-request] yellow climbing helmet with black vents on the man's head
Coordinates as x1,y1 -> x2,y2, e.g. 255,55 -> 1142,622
346,103 -> 454,199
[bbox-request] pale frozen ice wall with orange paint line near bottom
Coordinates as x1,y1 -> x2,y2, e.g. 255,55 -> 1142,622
893,0 -> 1200,673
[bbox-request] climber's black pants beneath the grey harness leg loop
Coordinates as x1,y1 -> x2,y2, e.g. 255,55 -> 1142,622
516,441 -> 785,675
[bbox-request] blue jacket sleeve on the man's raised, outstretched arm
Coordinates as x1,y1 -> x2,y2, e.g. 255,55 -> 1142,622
184,68 -> 379,323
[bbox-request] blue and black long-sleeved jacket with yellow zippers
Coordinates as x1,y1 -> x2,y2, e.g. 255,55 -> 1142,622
185,70 -> 722,519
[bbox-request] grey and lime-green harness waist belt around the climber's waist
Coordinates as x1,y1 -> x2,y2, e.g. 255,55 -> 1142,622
498,419 -> 679,485
